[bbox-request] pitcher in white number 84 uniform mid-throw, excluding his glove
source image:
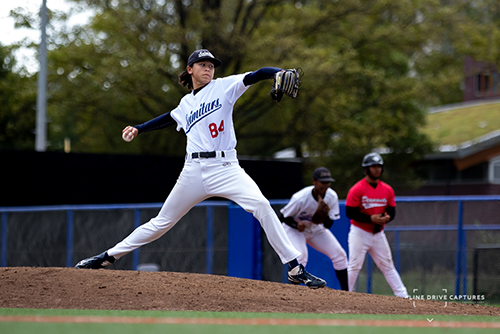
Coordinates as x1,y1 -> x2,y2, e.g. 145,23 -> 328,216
75,49 -> 326,288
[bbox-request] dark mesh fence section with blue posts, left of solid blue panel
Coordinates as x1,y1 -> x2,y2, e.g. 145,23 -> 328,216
1,202 -> 228,275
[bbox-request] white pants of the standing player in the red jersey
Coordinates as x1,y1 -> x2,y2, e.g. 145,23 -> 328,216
347,225 -> 408,298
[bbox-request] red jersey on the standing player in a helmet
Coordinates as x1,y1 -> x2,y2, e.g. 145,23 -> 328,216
345,179 -> 396,233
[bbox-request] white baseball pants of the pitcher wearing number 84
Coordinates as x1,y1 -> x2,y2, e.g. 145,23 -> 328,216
108,150 -> 300,264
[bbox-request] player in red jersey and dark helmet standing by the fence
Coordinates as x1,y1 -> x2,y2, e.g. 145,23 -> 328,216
345,153 -> 408,298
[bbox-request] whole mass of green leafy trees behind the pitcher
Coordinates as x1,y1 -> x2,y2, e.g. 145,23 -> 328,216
3,0 -> 500,196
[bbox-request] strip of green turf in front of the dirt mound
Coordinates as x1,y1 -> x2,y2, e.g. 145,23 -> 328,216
0,309 -> 500,334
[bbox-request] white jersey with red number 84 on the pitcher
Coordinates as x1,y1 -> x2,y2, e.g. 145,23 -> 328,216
170,73 -> 249,154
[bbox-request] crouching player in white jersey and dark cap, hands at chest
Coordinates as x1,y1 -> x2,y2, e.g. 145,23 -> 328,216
280,167 -> 349,291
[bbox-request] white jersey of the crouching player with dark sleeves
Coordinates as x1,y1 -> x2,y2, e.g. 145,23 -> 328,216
281,186 -> 340,231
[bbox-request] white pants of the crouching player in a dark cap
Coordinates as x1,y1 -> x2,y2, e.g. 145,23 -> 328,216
283,224 -> 347,270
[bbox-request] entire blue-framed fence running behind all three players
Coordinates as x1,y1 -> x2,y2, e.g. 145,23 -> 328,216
0,196 -> 500,295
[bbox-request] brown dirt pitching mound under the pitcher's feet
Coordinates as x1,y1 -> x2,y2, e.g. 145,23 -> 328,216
0,267 -> 500,316
